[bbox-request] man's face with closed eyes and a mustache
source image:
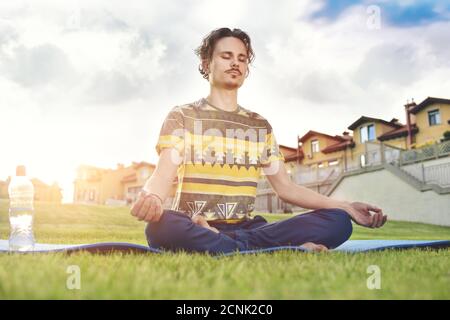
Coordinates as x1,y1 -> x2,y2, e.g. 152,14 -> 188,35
209,37 -> 248,90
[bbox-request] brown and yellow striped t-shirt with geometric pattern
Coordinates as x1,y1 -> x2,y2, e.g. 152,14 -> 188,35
156,98 -> 284,223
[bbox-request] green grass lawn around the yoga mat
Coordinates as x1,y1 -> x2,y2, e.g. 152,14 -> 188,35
0,200 -> 450,299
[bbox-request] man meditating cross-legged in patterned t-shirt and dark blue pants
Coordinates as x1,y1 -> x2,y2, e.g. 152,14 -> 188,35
131,28 -> 387,253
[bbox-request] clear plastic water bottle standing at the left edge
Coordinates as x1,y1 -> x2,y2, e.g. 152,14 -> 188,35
8,166 -> 35,251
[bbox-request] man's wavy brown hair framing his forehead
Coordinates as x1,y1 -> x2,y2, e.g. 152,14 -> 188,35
195,28 -> 255,80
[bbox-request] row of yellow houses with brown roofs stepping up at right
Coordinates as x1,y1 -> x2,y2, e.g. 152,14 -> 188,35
256,97 -> 450,212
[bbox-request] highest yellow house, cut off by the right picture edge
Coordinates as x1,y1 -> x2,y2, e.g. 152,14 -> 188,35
409,97 -> 450,148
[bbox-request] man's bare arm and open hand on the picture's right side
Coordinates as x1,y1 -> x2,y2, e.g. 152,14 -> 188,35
263,161 -> 387,228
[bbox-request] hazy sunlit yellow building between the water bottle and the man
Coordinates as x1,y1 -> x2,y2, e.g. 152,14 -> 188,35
74,162 -> 178,204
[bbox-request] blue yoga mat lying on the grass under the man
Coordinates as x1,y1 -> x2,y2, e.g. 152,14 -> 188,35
0,240 -> 450,256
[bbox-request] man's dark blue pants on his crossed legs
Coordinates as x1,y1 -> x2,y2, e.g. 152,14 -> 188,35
145,209 -> 353,253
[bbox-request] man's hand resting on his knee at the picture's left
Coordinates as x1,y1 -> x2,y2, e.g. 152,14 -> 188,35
131,192 -> 163,222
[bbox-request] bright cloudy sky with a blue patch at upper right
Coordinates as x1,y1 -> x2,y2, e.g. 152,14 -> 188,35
0,0 -> 450,202
